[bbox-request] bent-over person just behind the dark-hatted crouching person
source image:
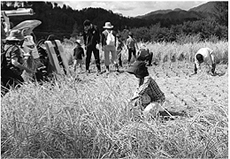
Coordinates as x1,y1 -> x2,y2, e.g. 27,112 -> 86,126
137,43 -> 153,66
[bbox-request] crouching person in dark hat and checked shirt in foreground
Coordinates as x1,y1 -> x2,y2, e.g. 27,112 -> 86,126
127,61 -> 187,120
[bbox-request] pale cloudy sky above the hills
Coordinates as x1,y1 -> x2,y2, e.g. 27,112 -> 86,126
53,0 -> 208,17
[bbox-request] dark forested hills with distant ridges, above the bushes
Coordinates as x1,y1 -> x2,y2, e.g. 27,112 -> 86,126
1,1 -> 228,37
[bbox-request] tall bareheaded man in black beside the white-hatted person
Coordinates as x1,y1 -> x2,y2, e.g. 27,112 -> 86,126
83,20 -> 101,74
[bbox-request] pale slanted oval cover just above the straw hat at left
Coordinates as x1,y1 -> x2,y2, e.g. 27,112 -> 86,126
12,20 -> 42,30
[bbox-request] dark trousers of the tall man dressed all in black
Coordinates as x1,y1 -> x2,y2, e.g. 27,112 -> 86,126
85,46 -> 101,71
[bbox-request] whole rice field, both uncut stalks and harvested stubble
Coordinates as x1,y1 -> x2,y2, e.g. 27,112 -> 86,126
1,43 -> 228,158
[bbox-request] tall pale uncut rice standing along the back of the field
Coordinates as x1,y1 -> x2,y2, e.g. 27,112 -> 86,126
64,41 -> 228,64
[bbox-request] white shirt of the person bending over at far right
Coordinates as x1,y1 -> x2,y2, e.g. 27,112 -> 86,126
195,48 -> 215,69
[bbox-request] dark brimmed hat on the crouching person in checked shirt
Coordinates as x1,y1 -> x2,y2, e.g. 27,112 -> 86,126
126,61 -> 149,78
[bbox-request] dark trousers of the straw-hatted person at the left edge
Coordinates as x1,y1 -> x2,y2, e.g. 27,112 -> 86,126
1,69 -> 24,96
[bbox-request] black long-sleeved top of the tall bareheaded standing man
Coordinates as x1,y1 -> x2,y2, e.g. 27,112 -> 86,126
83,25 -> 100,47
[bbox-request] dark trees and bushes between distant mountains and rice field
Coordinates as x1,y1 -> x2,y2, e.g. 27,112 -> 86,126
1,1 -> 228,42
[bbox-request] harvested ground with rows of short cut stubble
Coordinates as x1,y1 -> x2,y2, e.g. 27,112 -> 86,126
72,62 -> 228,116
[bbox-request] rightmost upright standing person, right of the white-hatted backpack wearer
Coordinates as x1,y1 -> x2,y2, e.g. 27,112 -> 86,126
126,32 -> 138,65
